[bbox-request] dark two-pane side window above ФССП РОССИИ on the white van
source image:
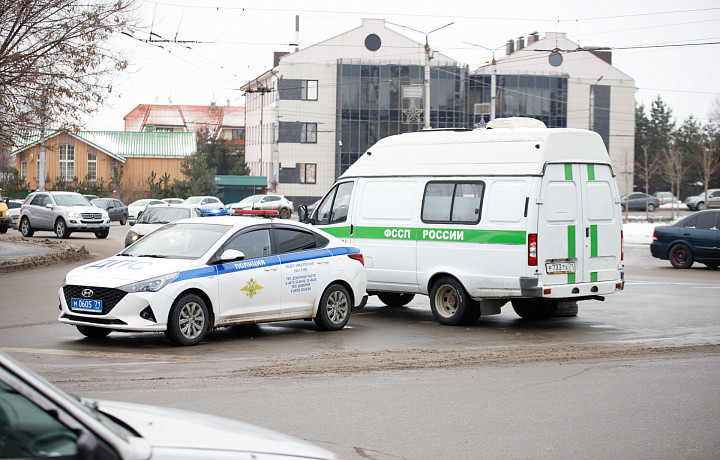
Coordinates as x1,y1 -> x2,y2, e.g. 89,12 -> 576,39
422,182 -> 485,224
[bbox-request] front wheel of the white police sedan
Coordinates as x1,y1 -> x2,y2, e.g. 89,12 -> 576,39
165,294 -> 209,345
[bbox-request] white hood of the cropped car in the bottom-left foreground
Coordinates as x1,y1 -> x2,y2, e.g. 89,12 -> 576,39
93,401 -> 337,459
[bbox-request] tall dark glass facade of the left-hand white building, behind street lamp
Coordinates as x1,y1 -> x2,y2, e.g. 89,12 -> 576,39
336,61 -> 468,175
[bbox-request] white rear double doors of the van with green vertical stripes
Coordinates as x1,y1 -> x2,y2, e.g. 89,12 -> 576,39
537,164 -> 622,286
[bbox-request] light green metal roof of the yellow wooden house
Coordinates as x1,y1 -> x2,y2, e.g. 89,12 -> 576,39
11,131 -> 197,163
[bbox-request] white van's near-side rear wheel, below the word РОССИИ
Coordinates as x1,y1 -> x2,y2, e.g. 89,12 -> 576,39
430,276 -> 480,326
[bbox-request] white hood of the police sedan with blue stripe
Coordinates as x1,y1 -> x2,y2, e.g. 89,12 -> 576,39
65,256 -> 199,288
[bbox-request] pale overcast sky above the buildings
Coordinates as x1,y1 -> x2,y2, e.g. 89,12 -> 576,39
87,0 -> 720,130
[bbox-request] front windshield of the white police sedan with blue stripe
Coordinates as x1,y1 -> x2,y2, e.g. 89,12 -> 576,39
120,223 -> 231,259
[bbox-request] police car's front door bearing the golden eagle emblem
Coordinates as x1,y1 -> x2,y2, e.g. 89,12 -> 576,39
217,225 -> 281,324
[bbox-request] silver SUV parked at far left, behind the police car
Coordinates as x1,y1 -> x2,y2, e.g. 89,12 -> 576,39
20,192 -> 110,238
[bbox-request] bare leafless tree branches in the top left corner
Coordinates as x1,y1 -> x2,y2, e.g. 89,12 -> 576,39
0,0 -> 135,148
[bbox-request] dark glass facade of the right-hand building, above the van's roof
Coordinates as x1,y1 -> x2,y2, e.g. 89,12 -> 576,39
468,74 -> 568,128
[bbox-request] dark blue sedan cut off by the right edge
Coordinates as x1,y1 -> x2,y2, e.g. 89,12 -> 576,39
650,211 -> 720,268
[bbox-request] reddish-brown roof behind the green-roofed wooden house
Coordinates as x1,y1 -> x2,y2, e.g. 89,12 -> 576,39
124,104 -> 245,135
